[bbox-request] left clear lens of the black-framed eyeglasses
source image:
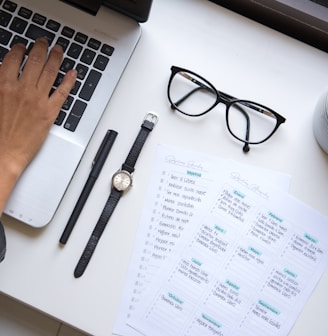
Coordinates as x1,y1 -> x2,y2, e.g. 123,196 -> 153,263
168,71 -> 217,116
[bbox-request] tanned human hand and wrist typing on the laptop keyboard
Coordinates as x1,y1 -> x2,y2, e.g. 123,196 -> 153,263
0,38 -> 76,214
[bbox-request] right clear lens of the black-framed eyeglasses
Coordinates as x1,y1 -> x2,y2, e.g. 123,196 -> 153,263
227,101 -> 277,144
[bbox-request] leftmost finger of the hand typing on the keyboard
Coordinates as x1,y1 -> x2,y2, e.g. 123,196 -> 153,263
0,43 -> 26,81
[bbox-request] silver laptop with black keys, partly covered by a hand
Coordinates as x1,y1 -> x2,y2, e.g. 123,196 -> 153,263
0,0 -> 152,227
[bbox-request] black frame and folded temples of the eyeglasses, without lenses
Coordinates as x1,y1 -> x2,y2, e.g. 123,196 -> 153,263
167,65 -> 286,153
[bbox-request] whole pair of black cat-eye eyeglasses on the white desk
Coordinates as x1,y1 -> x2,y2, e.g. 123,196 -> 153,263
167,66 -> 286,153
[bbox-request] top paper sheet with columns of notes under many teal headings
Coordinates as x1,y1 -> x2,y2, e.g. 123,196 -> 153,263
128,146 -> 328,336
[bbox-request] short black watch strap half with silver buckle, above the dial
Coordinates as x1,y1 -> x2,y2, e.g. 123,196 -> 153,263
122,112 -> 158,174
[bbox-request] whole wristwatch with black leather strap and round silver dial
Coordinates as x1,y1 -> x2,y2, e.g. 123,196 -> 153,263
74,112 -> 158,278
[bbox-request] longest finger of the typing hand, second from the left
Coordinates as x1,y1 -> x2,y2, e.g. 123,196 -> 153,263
21,38 -> 48,86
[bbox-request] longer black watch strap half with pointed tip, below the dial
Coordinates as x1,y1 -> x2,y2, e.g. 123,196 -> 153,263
74,188 -> 122,278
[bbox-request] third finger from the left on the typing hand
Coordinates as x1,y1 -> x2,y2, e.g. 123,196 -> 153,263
38,45 -> 63,93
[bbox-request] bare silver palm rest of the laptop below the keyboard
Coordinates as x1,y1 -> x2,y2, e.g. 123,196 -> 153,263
4,133 -> 84,227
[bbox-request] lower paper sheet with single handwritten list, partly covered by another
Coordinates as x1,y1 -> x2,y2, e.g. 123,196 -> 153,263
113,145 -> 290,336
